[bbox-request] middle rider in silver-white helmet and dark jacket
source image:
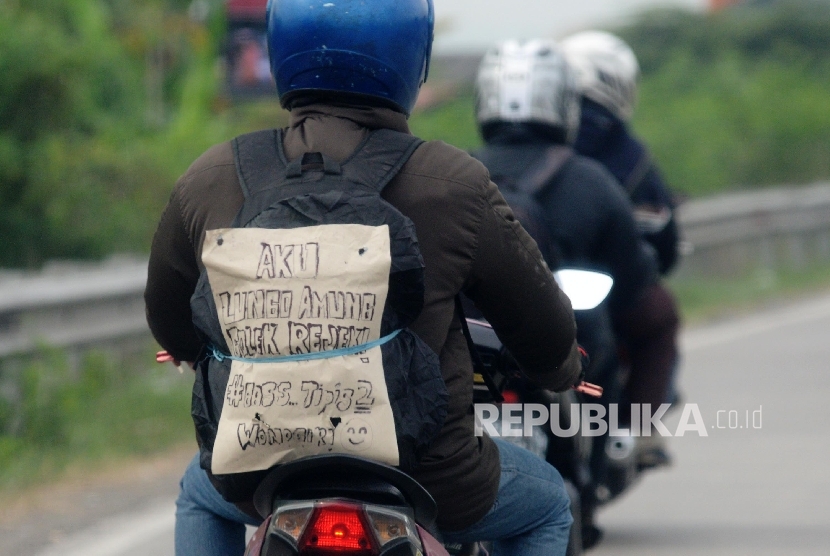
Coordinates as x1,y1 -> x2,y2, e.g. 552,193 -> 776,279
474,39 -> 677,544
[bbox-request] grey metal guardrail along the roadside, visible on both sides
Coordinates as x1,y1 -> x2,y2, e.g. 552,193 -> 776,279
0,184 -> 830,357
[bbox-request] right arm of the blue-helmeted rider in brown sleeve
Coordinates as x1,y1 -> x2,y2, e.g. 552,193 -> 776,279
465,178 -> 581,391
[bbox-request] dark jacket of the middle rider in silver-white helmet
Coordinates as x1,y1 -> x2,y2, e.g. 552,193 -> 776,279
475,125 -> 657,314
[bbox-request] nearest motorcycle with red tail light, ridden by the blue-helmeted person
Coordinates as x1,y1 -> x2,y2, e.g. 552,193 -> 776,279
156,271 -> 610,556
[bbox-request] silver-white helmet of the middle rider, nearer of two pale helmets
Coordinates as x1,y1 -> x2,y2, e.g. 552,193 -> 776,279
476,39 -> 579,141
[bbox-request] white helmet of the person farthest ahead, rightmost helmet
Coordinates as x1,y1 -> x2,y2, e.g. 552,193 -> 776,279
561,31 -> 640,121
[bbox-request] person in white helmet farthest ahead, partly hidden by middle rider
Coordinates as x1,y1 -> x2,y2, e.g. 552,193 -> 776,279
562,31 -> 680,466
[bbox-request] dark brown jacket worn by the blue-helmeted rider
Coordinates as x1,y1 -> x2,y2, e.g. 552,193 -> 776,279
145,105 -> 580,530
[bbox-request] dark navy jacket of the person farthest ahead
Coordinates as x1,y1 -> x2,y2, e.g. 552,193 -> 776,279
574,99 -> 680,274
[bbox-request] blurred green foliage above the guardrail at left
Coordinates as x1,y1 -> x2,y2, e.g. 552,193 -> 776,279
0,0 -> 228,267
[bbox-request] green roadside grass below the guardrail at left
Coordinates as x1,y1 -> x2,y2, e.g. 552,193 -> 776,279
0,348 -> 193,491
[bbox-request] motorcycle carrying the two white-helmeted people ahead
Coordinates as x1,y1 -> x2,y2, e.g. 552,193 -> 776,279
468,269 -> 660,556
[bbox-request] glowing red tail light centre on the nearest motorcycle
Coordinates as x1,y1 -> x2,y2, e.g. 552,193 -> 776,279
299,503 -> 379,556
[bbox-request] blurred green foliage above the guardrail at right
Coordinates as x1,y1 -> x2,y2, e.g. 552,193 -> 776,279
617,2 -> 830,196
